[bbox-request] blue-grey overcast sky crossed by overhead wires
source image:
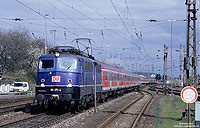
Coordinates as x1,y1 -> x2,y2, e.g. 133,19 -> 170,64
0,0 -> 199,73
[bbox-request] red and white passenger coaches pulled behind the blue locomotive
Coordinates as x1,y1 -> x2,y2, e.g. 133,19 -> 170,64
101,65 -> 140,91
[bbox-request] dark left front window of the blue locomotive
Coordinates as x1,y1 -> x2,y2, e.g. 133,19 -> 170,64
39,59 -> 54,69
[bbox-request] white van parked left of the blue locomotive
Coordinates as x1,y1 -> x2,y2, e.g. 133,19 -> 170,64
10,82 -> 29,92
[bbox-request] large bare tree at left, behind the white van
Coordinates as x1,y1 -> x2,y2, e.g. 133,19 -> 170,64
0,29 -> 44,74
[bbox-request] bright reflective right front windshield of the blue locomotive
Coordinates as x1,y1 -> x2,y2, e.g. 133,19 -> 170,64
58,58 -> 77,70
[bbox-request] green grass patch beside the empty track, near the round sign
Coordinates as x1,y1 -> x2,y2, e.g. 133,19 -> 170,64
155,96 -> 194,128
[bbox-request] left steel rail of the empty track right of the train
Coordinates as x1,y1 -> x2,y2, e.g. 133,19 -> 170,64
98,92 -> 144,128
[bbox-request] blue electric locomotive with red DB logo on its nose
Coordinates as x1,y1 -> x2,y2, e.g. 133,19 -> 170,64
35,47 -> 102,108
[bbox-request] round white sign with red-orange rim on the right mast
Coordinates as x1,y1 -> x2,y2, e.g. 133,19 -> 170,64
181,86 -> 198,103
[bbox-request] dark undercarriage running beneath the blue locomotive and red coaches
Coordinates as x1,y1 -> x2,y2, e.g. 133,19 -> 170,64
36,86 -> 139,113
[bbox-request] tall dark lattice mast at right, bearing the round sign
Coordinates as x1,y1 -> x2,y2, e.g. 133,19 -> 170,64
184,0 -> 197,127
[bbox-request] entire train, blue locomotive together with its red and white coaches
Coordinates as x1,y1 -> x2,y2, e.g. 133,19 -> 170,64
35,46 -> 140,110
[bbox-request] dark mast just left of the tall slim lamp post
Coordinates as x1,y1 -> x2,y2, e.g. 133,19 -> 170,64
163,45 -> 168,93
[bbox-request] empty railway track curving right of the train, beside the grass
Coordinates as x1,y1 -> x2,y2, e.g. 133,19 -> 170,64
99,91 -> 154,128
